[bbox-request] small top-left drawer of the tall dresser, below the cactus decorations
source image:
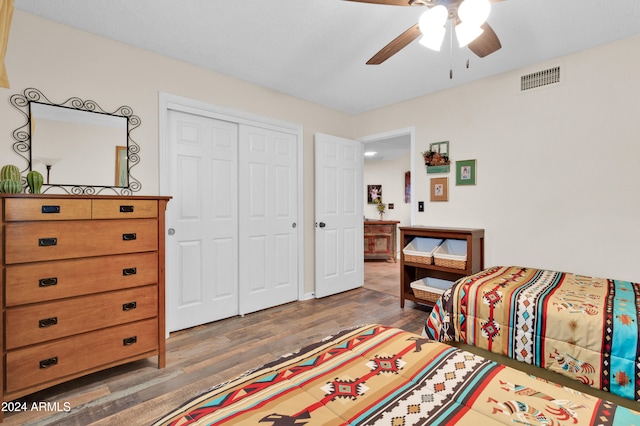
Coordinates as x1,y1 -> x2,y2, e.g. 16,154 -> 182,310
4,198 -> 91,222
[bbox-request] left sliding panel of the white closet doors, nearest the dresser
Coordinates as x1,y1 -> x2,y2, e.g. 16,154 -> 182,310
163,110 -> 239,332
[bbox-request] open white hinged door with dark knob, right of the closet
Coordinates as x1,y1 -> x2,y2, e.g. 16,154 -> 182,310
315,134 -> 364,297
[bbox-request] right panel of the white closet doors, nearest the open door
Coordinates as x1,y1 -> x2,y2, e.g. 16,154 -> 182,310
239,125 -> 299,314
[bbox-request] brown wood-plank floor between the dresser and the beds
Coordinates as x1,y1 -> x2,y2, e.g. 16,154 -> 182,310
4,262 -> 428,426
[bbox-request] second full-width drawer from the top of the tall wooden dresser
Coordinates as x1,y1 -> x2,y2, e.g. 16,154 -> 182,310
5,252 -> 158,307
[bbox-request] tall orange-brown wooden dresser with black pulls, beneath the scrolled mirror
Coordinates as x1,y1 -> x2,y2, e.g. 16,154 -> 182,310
0,194 -> 169,412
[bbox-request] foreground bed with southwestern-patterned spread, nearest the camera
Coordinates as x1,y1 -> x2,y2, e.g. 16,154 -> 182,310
155,325 -> 640,426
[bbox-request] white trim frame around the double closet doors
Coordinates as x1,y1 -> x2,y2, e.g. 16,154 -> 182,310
158,92 -> 305,326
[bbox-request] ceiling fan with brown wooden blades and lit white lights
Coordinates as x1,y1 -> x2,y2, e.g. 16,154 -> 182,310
346,0 -> 502,65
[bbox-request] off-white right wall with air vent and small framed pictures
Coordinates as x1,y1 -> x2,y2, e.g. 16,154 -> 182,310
356,36 -> 640,281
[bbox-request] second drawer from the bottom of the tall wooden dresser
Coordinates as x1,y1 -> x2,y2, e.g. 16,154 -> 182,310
5,285 -> 158,349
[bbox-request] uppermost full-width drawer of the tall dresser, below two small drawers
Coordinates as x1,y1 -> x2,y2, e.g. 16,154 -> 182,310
5,219 -> 158,264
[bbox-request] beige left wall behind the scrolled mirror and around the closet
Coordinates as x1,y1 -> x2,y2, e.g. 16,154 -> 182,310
0,10 -> 352,292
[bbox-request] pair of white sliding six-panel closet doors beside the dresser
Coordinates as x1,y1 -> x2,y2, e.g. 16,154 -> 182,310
166,110 -> 298,332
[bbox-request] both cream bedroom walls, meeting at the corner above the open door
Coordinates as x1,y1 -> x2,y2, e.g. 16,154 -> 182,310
0,11 -> 640,292
